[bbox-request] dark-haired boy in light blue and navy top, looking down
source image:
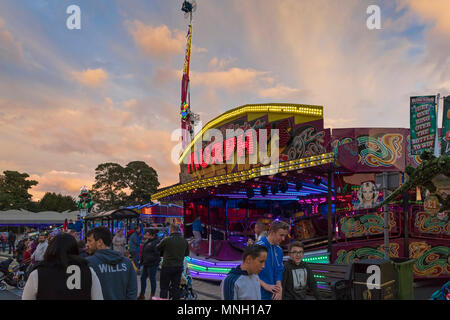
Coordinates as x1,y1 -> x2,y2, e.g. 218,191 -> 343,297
220,244 -> 267,300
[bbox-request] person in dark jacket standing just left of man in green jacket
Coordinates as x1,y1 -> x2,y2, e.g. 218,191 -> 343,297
138,229 -> 161,300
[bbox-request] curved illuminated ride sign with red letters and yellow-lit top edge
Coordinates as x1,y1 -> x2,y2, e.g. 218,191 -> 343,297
180,104 -> 330,183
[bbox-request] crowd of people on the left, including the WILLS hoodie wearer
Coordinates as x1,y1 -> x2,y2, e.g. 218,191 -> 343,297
5,223 -> 189,300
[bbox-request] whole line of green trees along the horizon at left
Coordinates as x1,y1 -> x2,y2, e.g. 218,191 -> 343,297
0,161 -> 159,212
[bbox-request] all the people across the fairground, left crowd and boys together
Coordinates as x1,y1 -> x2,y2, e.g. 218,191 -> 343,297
2,219 -> 321,300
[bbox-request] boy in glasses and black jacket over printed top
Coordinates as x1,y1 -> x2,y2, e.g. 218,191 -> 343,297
282,241 -> 321,300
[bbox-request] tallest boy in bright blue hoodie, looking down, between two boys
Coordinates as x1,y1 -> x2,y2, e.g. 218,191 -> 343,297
256,221 -> 289,300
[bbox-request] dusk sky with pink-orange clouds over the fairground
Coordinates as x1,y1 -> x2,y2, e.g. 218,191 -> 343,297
0,0 -> 450,200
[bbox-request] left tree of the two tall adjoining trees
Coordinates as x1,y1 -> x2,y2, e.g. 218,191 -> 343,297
91,162 -> 127,211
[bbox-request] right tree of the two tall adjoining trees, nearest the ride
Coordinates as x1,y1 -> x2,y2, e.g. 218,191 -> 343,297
125,161 -> 159,205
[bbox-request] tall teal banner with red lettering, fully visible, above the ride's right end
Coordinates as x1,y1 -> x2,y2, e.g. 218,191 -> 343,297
410,96 -> 437,155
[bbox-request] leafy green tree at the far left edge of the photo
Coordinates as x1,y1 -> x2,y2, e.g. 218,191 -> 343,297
0,171 -> 38,210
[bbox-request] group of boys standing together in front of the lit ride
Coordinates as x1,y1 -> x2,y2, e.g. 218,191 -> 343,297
221,221 -> 321,300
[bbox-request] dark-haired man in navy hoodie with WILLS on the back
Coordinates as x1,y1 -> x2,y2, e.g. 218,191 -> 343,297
86,227 -> 137,300
